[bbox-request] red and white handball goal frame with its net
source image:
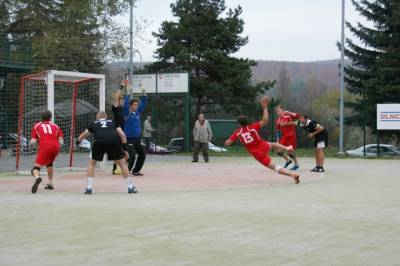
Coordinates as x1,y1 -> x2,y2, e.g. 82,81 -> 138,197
15,70 -> 105,173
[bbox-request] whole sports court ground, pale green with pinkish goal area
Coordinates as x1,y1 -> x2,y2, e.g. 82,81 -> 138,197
0,157 -> 400,266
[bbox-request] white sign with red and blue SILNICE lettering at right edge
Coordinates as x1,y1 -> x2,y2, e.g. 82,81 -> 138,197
376,104 -> 400,130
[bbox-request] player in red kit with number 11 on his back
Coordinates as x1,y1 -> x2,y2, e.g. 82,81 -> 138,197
30,111 -> 64,193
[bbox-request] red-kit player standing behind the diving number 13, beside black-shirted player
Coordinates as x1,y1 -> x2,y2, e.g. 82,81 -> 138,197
275,105 -> 299,170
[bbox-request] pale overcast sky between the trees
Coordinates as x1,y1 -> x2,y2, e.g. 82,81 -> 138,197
116,0 -> 365,62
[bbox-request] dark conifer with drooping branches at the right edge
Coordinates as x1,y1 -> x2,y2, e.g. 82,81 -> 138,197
345,0 -> 400,139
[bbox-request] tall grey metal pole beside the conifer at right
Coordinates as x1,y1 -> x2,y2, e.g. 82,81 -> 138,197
339,0 -> 345,155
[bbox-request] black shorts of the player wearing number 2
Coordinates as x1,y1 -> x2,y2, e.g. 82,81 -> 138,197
91,140 -> 124,162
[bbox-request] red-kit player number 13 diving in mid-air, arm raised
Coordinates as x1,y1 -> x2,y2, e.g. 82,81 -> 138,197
225,98 -> 300,184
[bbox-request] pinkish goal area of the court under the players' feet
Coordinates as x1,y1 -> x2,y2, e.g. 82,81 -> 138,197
0,157 -> 323,193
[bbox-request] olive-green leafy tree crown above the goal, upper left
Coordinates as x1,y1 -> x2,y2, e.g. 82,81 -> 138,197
0,0 -> 128,72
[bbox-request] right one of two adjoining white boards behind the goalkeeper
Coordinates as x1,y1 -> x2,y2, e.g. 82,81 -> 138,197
157,73 -> 189,93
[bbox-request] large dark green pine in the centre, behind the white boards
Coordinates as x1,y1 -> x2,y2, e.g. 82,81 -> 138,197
146,0 -> 271,115
